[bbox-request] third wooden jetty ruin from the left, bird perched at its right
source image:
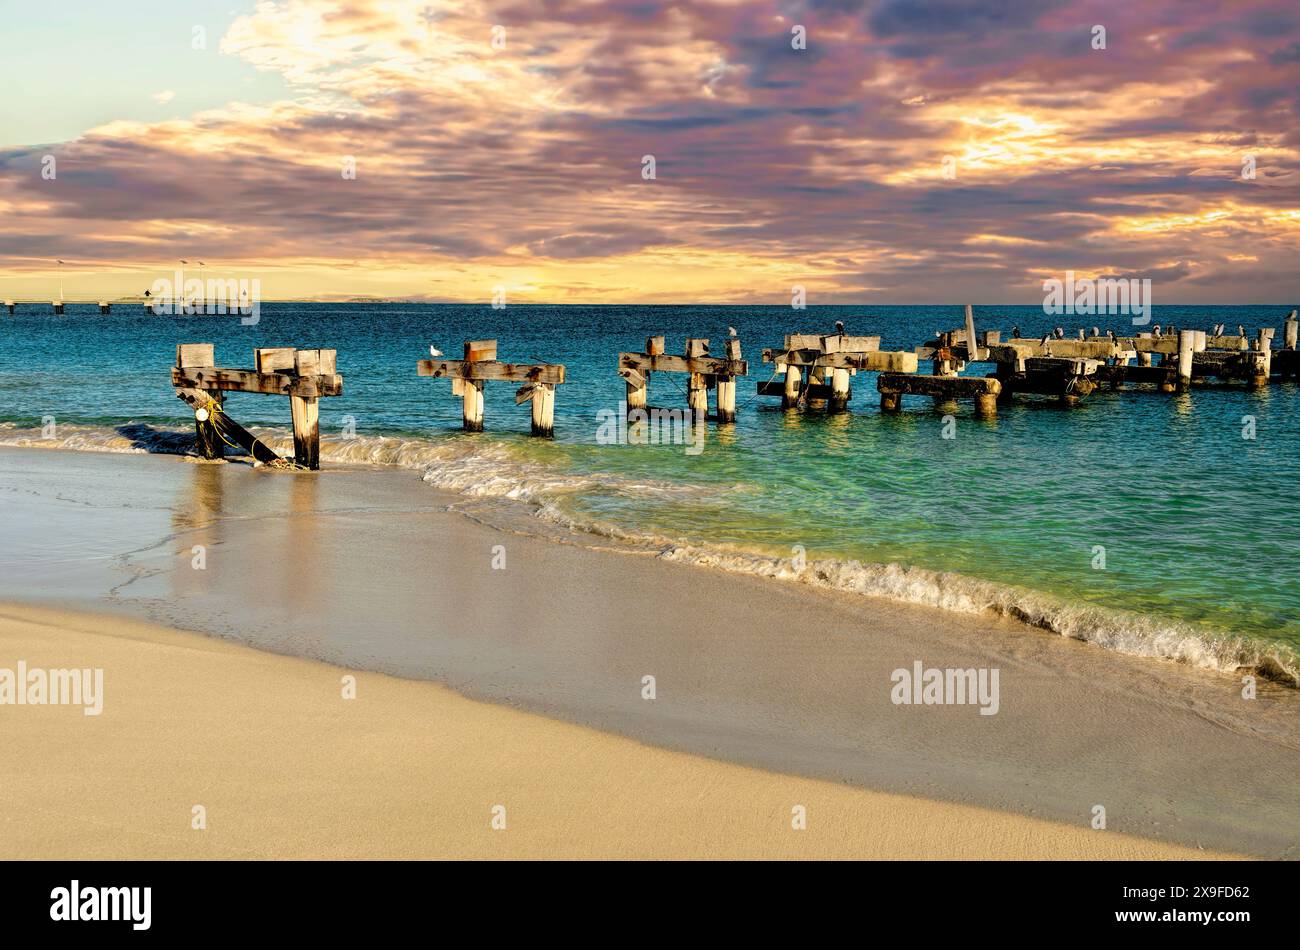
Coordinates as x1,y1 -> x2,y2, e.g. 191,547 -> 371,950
619,337 -> 749,422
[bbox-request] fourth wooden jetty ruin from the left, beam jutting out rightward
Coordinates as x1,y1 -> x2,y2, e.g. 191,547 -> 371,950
758,327 -> 918,412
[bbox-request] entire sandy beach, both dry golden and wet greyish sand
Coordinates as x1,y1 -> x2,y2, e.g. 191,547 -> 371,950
0,450 -> 1300,858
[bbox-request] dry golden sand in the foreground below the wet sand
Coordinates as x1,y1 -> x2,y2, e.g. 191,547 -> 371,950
0,604 -> 1225,859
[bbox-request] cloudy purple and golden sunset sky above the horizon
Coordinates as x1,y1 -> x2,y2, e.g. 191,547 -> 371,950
0,0 -> 1300,305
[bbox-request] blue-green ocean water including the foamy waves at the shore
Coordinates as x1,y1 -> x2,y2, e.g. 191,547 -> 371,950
0,303 -> 1300,676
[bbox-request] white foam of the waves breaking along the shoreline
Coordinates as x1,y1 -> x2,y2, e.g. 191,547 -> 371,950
0,422 -> 1300,686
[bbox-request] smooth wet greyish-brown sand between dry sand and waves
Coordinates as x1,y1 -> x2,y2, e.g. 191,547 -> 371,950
0,450 -> 1300,858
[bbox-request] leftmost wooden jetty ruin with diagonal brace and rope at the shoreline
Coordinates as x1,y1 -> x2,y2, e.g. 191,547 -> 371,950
172,343 -> 343,469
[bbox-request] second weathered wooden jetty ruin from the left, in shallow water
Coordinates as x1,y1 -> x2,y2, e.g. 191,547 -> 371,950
416,339 -> 564,438
